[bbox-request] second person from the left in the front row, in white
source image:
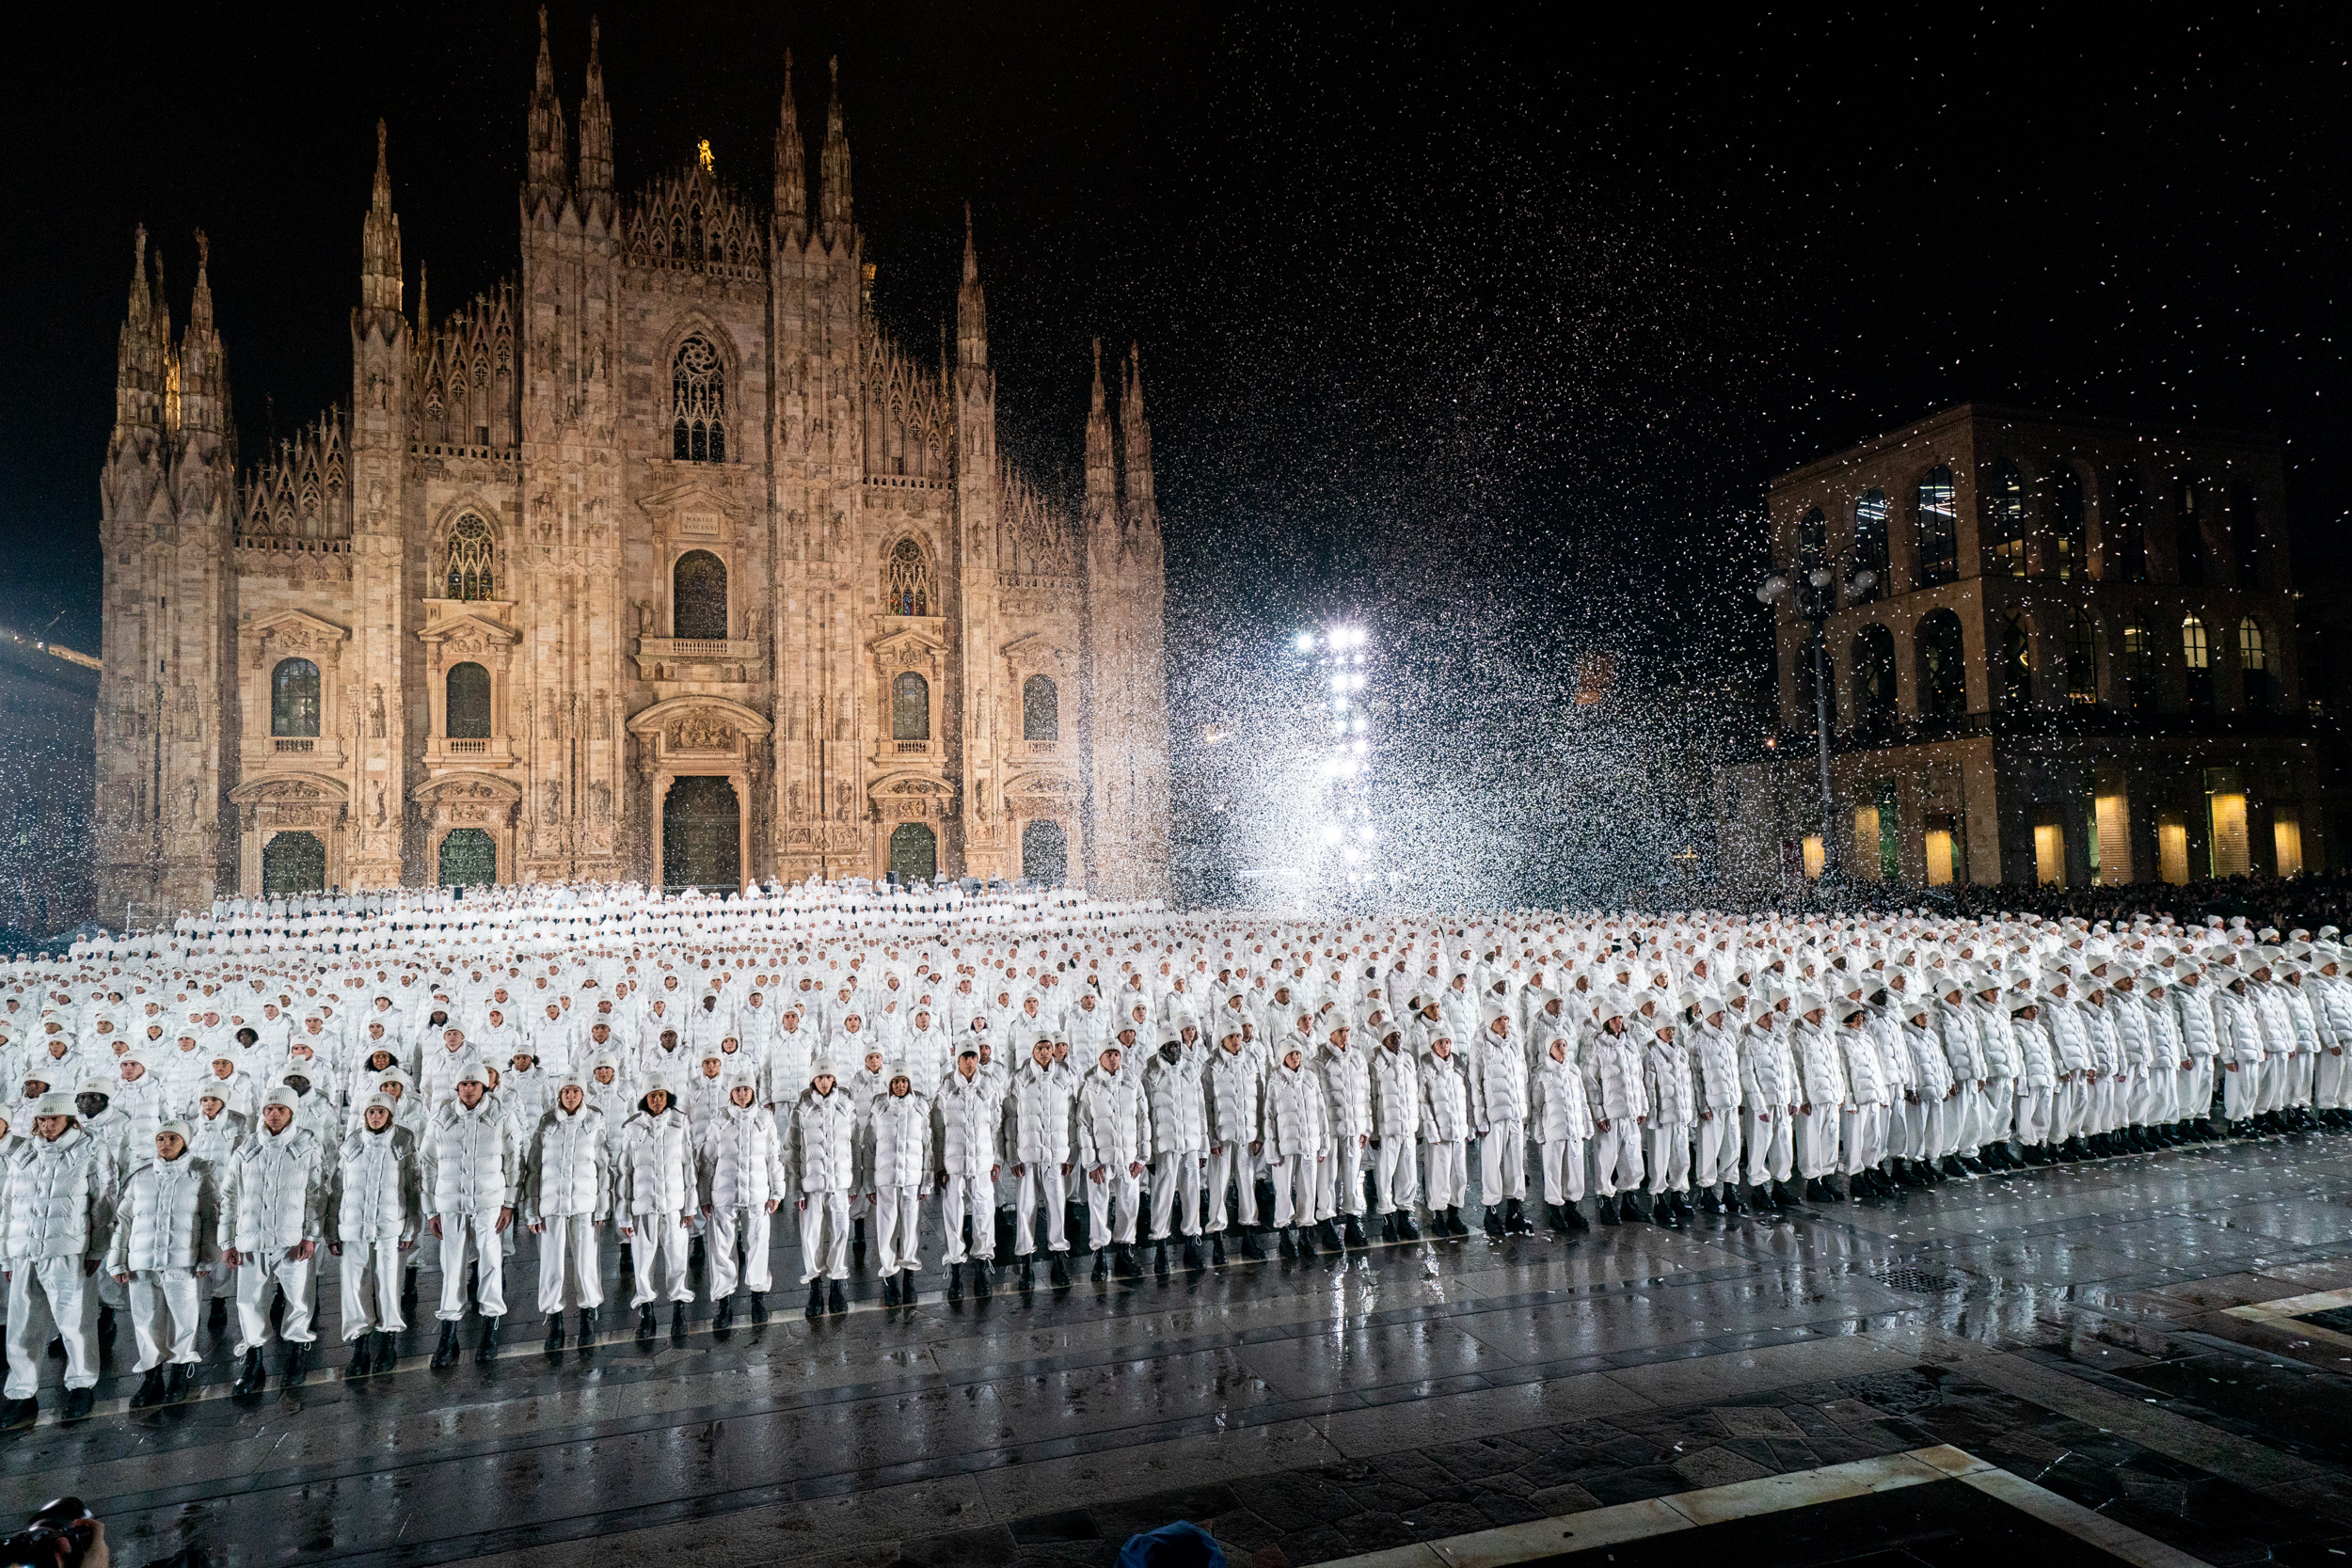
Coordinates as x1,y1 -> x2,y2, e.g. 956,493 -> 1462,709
106,1119 -> 221,1411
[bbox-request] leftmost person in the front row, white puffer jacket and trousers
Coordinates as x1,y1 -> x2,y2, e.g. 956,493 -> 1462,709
0,1093 -> 116,1430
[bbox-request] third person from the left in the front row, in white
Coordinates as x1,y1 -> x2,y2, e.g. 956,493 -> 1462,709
221,1088 -> 327,1397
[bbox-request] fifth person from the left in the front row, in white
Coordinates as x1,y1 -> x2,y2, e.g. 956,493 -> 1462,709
419,1053 -> 522,1369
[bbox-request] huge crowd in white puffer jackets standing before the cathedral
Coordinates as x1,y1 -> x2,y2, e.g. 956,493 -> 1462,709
0,884 -> 2352,1427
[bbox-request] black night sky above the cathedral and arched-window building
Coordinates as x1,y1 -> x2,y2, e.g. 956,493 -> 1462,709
0,0 -> 2352,690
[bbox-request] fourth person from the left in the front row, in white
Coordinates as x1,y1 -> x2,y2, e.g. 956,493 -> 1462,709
327,1093 -> 423,1380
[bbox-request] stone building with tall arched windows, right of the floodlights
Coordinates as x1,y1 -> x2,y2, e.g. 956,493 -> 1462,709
1717,404 -> 2352,886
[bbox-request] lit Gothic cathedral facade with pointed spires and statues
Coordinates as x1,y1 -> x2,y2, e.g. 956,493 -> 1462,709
97,19 -> 1169,919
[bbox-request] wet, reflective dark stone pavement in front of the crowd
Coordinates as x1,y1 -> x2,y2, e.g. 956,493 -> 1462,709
13,1135 -> 2352,1568
